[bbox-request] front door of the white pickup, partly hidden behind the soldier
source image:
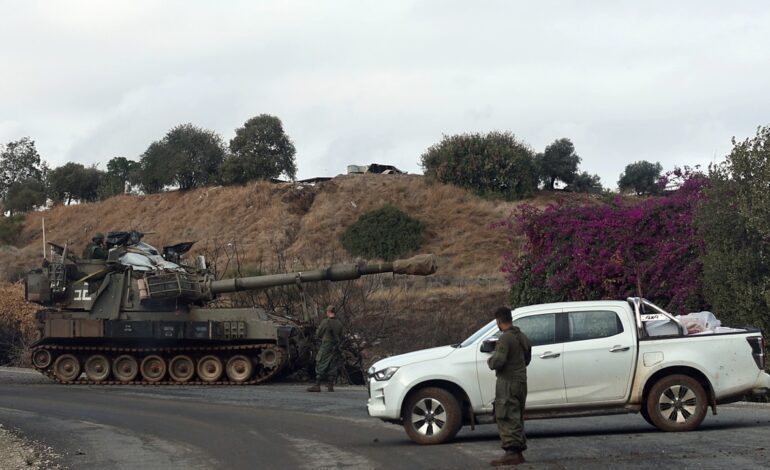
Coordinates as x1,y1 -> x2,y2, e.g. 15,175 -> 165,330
476,311 -> 566,409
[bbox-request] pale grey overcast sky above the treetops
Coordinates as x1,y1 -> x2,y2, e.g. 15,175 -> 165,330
0,0 -> 770,188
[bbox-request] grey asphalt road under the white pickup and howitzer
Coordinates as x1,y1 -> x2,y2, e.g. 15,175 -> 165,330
0,368 -> 770,470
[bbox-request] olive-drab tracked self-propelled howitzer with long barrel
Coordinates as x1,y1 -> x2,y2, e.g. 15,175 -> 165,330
25,232 -> 436,384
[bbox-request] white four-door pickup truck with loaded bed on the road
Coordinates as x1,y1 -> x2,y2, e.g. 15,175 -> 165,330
367,297 -> 770,444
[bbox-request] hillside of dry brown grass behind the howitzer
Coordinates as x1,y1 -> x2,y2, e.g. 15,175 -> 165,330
0,175 -> 588,364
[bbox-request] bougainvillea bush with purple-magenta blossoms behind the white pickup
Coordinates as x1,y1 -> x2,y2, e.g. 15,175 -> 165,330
502,174 -> 705,313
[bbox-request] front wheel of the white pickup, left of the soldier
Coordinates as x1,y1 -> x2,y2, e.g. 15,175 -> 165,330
403,387 -> 462,444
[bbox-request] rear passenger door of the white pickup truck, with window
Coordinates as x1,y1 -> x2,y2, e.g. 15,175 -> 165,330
559,308 -> 637,403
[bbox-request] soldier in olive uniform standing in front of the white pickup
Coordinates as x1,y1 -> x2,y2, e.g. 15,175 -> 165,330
487,307 -> 532,467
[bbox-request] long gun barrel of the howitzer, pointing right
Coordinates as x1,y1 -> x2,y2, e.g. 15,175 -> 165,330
210,255 -> 436,294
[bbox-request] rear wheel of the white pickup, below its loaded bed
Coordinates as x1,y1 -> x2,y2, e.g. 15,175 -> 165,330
647,375 -> 707,432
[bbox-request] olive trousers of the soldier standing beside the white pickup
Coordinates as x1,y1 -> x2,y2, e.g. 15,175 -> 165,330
495,377 -> 527,452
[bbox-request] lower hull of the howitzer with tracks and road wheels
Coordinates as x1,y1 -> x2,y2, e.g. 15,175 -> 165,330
32,308 -> 300,385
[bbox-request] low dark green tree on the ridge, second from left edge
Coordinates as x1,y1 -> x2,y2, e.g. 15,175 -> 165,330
48,162 -> 104,204
